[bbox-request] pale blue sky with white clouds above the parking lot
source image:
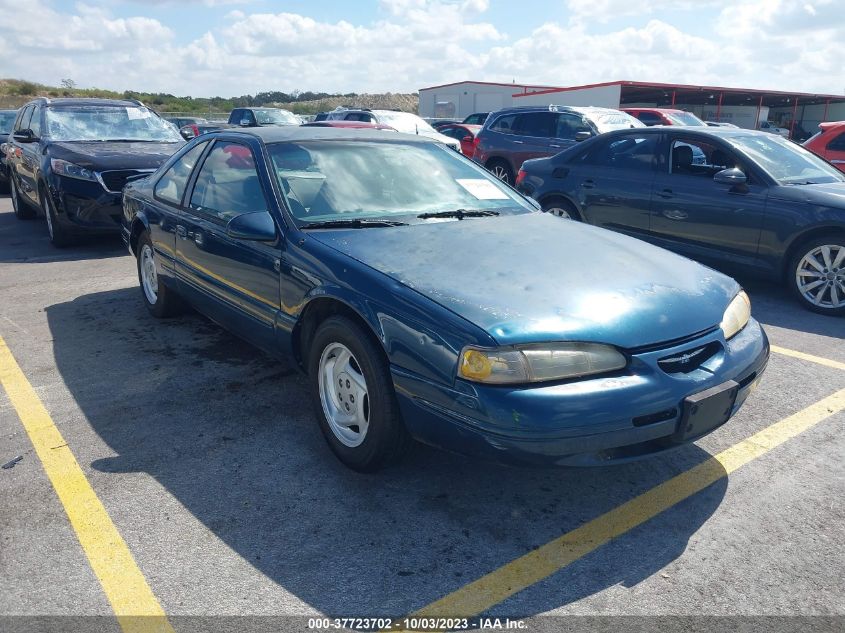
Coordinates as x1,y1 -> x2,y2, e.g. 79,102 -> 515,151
0,0 -> 845,96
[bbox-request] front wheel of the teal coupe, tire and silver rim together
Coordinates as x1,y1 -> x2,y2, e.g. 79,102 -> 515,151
308,316 -> 410,472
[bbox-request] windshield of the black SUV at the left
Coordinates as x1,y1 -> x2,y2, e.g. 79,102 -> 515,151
47,105 -> 182,143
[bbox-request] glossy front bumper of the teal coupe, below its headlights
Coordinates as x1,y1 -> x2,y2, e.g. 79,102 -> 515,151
392,319 -> 769,466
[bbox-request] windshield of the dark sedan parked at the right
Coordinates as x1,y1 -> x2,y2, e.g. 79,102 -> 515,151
726,134 -> 845,185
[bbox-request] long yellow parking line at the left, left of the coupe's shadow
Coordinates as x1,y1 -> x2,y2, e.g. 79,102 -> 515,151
0,337 -> 173,633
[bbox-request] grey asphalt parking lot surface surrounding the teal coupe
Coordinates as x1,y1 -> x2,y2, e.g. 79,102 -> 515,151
0,195 -> 845,631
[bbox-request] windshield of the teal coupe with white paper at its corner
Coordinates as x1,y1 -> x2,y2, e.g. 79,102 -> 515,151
268,140 -> 535,224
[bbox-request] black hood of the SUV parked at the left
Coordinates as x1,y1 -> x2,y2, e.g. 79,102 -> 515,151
50,141 -> 185,171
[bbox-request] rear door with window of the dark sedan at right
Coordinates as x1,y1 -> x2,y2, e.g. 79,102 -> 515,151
566,131 -> 662,237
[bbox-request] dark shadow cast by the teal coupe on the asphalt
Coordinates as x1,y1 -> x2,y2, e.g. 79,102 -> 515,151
47,288 -> 727,616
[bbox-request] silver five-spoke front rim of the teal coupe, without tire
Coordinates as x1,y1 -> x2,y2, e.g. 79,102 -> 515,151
319,343 -> 370,448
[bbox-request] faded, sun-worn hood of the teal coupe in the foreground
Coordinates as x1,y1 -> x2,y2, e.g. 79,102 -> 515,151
309,213 -> 739,349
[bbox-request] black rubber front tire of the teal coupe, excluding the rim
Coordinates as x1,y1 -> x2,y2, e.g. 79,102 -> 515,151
308,317 -> 404,472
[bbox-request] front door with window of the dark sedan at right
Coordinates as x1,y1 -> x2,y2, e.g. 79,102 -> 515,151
651,134 -> 768,266
